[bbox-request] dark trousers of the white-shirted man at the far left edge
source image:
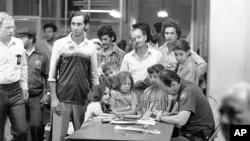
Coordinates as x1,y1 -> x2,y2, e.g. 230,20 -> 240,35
0,81 -> 27,141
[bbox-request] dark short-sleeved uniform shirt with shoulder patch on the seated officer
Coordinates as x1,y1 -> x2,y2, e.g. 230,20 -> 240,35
178,80 -> 215,134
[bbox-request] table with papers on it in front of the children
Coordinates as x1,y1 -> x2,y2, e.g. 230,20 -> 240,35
65,122 -> 174,141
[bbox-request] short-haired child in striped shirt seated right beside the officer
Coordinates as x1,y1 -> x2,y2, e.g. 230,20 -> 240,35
137,64 -> 178,115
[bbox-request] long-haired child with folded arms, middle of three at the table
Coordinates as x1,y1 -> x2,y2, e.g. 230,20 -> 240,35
110,71 -> 138,115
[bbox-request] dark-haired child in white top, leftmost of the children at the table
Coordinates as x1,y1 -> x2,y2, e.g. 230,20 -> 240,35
84,85 -> 115,123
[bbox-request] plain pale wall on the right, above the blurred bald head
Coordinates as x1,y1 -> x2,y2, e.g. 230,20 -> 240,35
208,0 -> 250,140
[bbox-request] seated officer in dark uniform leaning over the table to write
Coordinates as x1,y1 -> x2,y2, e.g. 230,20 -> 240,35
157,69 -> 215,141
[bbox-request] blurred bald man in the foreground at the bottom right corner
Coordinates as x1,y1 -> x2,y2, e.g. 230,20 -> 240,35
220,82 -> 250,141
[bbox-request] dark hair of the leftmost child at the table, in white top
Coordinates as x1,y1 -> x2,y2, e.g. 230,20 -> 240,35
88,85 -> 107,102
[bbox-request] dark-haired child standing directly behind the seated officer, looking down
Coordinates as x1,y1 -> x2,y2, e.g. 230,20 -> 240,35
174,39 -> 200,85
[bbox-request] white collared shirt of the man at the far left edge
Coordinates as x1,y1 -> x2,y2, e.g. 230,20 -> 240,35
0,37 -> 28,90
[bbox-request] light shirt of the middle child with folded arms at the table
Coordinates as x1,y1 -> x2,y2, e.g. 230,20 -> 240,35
110,91 -> 138,109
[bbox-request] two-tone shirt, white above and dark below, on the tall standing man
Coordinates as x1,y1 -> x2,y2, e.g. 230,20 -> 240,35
49,33 -> 99,104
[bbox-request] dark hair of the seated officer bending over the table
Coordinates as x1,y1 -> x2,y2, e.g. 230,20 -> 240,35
159,69 -> 181,87
